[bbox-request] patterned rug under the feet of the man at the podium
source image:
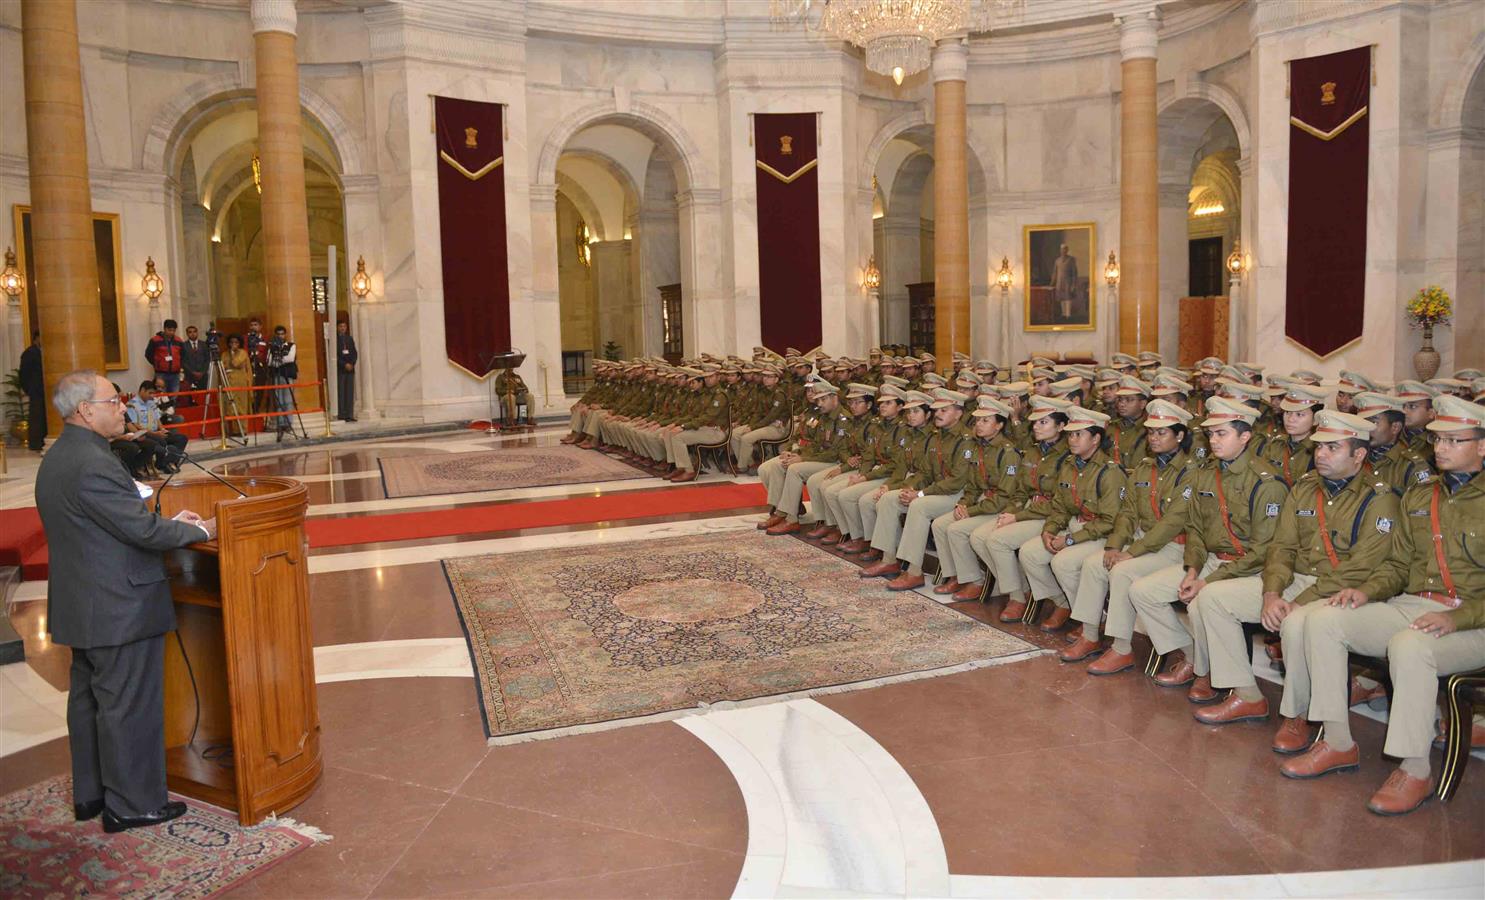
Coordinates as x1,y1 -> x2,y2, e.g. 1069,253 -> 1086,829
0,775 -> 330,897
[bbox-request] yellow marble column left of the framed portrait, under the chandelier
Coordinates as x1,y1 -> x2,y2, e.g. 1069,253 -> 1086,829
933,39 -> 974,367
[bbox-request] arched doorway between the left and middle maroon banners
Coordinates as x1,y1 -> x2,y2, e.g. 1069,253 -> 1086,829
555,120 -> 686,380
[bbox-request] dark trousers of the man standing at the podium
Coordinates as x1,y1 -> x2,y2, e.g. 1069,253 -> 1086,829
67,634 -> 168,815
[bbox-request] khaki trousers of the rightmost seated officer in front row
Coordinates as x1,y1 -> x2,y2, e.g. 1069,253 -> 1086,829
1306,594 -> 1485,759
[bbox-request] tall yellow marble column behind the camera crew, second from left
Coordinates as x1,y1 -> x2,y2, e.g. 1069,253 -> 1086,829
252,0 -> 319,408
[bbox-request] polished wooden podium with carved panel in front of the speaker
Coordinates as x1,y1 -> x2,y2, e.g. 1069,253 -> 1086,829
160,477 -> 324,826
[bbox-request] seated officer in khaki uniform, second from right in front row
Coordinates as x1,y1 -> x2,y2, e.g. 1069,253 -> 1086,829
1195,409 -> 1397,733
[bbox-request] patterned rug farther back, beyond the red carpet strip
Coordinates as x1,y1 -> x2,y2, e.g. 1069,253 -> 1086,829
377,444 -> 649,499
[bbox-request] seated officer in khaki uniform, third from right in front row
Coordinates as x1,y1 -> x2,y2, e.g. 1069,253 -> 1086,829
1129,397 -> 1287,702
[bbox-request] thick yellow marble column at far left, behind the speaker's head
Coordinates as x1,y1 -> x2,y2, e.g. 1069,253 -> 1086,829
16,0 -> 101,435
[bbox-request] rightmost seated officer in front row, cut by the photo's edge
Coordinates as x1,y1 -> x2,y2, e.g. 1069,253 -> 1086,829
1285,397 -> 1485,815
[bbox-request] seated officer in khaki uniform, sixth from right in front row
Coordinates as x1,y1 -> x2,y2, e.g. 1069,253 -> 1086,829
970,397 -> 1072,622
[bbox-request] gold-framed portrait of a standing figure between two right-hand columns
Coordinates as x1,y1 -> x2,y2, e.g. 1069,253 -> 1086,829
1023,221 -> 1097,331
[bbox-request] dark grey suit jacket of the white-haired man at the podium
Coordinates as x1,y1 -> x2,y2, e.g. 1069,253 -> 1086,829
36,425 -> 205,648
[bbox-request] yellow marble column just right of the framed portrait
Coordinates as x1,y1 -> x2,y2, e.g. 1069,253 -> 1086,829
1115,10 -> 1160,353
